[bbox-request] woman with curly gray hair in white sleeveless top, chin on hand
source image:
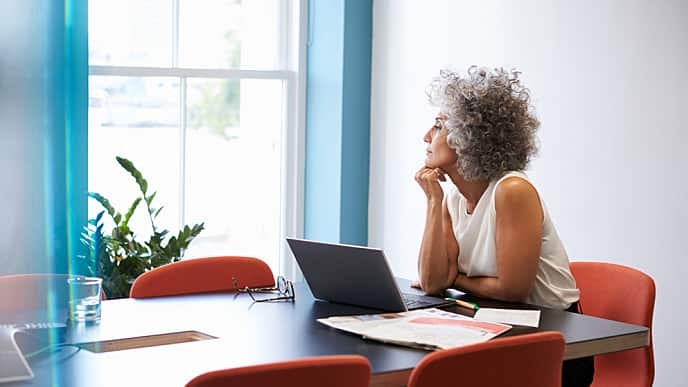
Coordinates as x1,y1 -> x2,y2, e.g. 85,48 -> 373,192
416,67 -> 593,386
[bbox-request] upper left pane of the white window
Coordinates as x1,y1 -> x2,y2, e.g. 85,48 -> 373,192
88,0 -> 173,67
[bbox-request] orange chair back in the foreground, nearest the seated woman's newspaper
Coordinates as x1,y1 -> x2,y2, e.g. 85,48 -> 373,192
408,332 -> 564,387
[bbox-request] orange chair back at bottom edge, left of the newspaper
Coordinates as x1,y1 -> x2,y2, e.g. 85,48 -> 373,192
186,355 -> 370,387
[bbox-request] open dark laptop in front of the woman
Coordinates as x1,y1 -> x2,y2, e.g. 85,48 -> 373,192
287,238 -> 451,312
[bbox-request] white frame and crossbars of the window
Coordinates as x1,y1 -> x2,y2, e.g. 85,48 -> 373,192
88,0 -> 308,280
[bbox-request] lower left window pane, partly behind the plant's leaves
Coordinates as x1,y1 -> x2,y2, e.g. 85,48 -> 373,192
88,76 -> 180,241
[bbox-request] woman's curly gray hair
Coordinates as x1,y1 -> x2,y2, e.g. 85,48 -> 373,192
427,66 -> 540,181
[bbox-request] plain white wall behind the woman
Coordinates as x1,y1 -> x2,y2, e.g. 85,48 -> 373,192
369,0 -> 688,387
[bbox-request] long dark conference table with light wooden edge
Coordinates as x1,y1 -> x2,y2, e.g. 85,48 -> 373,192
6,280 -> 649,386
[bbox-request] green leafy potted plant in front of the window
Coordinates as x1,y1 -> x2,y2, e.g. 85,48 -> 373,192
81,156 -> 204,298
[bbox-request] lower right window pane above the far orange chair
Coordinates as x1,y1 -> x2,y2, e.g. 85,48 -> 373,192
186,79 -> 283,272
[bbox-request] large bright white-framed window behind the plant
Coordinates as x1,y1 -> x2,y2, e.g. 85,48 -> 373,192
88,0 -> 304,272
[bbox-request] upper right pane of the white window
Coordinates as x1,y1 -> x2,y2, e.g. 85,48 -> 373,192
179,0 -> 285,70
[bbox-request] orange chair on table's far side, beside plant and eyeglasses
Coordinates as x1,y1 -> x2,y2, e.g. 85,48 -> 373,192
129,257 -> 275,298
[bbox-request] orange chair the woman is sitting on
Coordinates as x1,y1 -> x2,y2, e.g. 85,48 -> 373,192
571,262 -> 655,387
